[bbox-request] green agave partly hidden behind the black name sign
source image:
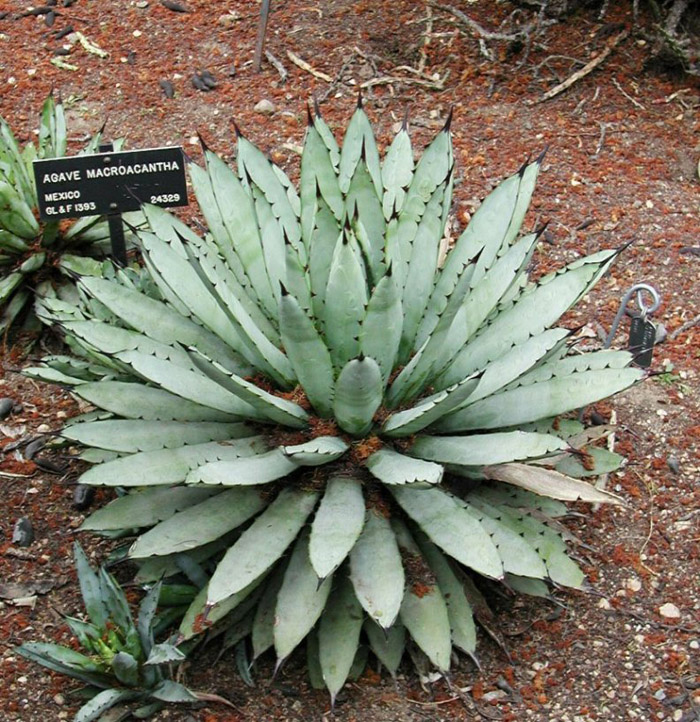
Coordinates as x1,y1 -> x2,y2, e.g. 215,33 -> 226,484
0,95 -> 141,331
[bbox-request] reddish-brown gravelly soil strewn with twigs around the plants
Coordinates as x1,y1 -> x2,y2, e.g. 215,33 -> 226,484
0,0 -> 700,722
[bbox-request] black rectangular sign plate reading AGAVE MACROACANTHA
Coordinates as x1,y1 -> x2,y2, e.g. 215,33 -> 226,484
34,146 -> 187,221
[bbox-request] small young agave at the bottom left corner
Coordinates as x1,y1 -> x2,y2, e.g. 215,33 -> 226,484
17,543 -> 224,722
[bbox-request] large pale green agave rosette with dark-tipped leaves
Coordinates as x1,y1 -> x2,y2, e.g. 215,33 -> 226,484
29,101 -> 643,697
